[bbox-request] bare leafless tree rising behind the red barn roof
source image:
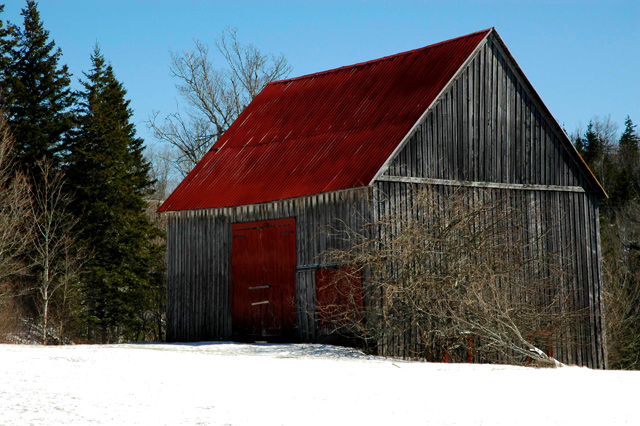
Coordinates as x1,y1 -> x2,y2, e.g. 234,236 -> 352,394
148,28 -> 291,175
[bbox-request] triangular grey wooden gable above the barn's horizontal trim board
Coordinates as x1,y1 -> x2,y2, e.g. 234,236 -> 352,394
386,36 -> 587,188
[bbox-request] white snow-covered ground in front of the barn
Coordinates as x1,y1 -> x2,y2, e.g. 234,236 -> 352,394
0,343 -> 640,426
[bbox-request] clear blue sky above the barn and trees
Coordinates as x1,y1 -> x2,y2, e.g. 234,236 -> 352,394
0,0 -> 640,142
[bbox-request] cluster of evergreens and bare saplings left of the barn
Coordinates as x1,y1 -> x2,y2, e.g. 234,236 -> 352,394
0,0 -> 164,343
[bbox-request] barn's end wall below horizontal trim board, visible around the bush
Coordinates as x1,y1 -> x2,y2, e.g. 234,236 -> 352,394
374,181 -> 605,368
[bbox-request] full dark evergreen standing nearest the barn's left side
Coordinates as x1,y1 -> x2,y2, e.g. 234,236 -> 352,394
66,46 -> 158,342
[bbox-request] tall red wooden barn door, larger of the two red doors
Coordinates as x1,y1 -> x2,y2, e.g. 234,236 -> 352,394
231,218 -> 296,337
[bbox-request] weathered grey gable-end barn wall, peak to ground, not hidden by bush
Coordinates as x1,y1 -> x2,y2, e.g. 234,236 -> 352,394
375,33 -> 606,368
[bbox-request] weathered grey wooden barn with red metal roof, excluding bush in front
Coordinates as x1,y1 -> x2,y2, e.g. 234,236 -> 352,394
159,28 -> 606,368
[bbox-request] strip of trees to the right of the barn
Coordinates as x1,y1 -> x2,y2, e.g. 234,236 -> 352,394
571,117 -> 640,370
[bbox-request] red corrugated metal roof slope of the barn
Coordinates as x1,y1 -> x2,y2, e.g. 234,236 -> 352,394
159,30 -> 490,211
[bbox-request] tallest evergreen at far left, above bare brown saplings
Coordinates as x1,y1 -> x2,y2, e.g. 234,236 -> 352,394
0,0 -> 74,174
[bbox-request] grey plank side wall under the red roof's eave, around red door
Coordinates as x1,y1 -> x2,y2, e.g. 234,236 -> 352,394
167,188 -> 371,341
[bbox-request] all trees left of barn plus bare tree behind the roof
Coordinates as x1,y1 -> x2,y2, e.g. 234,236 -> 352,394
0,0 -> 291,343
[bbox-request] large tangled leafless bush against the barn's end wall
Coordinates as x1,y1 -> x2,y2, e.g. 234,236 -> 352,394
317,189 -> 582,365
